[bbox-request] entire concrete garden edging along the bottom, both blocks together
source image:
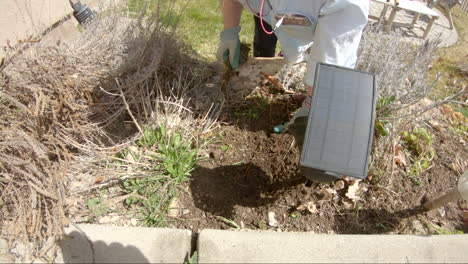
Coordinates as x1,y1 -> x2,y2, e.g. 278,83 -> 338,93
46,225 -> 468,263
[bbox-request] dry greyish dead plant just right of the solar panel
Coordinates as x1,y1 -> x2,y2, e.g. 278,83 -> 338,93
356,26 -> 462,120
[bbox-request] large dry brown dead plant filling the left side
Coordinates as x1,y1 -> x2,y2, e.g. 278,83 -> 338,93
0,1 -> 213,257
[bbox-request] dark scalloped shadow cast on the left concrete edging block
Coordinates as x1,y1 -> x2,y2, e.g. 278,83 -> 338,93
57,231 -> 150,263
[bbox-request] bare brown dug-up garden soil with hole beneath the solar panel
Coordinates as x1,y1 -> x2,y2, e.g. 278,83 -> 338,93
173,85 -> 468,234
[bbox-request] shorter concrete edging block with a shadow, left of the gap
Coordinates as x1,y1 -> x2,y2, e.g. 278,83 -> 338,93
55,225 -> 192,263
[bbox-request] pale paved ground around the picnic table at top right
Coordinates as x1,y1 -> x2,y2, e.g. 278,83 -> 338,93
369,0 -> 458,47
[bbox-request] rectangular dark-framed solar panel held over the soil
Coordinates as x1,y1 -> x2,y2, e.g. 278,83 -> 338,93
300,63 -> 376,181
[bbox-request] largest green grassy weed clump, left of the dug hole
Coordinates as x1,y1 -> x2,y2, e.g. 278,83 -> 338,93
120,124 -> 198,227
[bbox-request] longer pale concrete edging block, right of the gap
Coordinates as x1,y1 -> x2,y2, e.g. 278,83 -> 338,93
198,229 -> 468,263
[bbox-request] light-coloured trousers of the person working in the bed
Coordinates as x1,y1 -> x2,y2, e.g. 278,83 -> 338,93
239,0 -> 369,86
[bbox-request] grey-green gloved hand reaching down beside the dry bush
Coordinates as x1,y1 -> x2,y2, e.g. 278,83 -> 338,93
216,26 -> 241,69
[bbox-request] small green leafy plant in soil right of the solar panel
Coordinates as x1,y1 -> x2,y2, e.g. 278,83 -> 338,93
401,128 -> 435,185
